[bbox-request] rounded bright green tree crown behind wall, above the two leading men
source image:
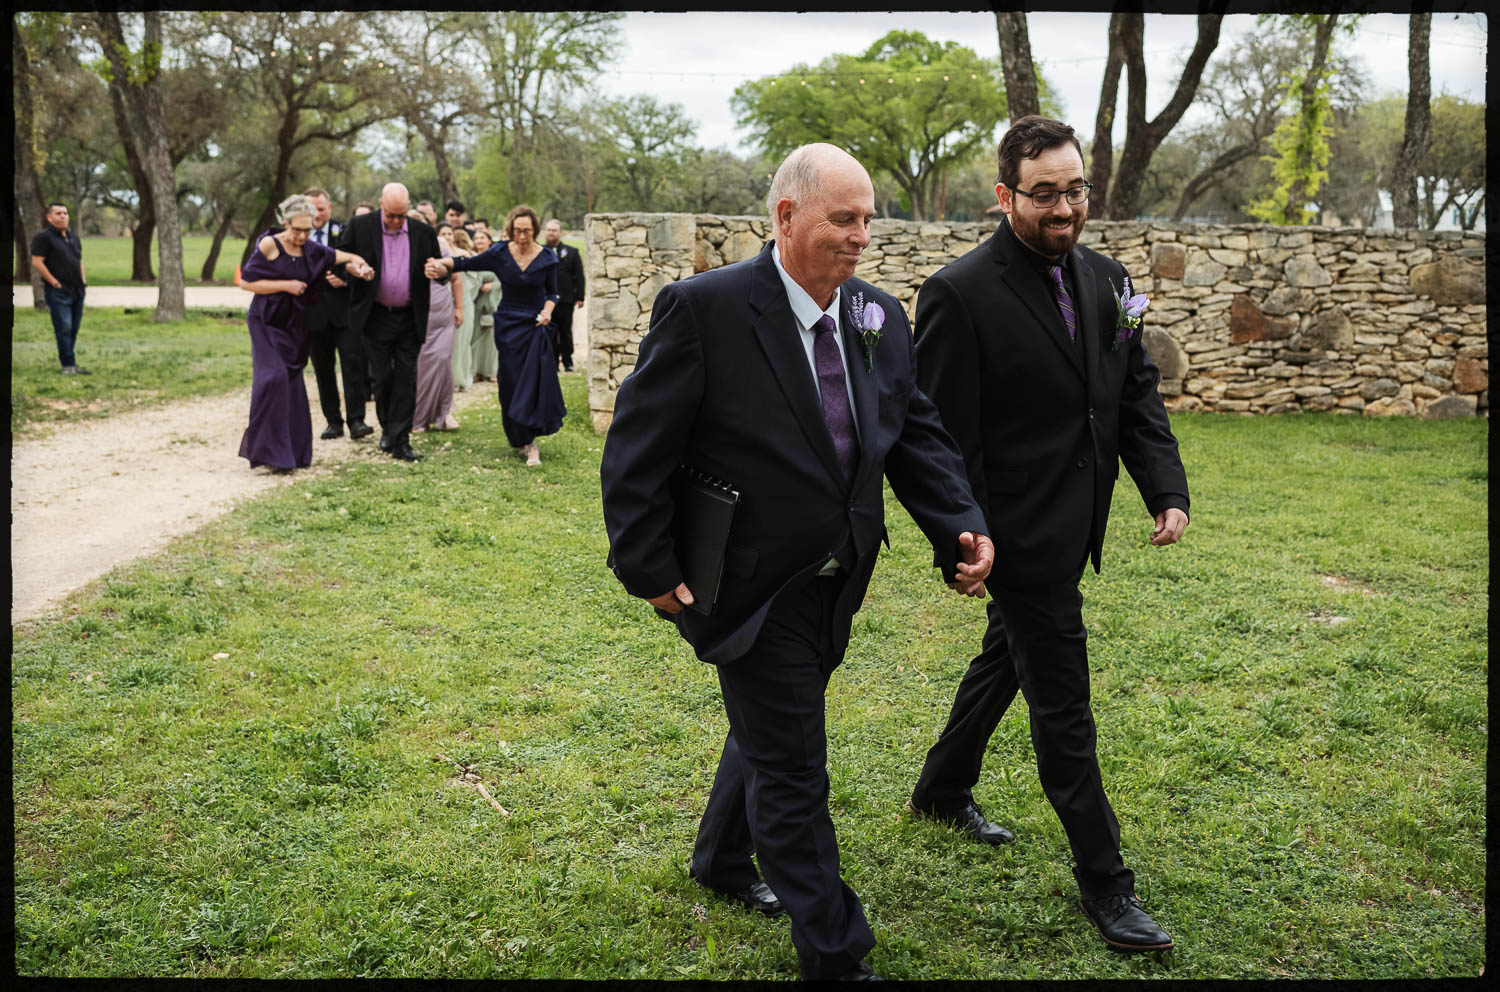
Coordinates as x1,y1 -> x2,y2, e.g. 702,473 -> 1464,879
732,32 -> 1007,218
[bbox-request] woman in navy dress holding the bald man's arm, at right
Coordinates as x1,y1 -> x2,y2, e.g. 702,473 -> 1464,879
428,206 -> 567,465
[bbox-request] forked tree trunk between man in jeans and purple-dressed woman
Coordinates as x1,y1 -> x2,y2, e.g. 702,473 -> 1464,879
99,11 -> 185,321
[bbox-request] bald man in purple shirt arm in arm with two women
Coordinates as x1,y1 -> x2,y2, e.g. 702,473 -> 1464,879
336,183 -> 447,462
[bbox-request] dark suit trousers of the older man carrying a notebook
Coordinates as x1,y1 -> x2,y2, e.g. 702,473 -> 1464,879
693,576 -> 875,978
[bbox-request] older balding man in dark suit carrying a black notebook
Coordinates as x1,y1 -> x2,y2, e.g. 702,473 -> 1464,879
600,144 -> 993,978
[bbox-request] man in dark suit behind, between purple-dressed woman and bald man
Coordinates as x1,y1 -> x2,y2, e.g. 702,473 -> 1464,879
302,186 -> 375,441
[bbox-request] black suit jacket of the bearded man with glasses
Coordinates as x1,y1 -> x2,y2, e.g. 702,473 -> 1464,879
917,221 -> 1188,584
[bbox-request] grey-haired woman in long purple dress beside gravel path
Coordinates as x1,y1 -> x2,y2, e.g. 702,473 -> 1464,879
240,195 -> 375,471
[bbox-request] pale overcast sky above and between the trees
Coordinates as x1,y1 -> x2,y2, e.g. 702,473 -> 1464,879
599,12 -> 1487,153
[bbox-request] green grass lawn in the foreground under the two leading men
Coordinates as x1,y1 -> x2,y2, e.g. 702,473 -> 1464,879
12,375 -> 1490,978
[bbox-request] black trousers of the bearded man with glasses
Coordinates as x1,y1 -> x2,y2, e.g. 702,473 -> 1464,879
912,566 -> 1136,899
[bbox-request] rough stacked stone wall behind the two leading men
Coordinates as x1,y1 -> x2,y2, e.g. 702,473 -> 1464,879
585,213 -> 1490,431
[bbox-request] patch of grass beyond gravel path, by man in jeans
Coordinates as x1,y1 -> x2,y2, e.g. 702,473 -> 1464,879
11,306 -> 251,437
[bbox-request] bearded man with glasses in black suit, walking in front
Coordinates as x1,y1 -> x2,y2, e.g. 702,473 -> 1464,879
912,116 -> 1188,950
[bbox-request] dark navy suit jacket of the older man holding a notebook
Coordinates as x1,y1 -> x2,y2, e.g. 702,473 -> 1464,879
600,246 -> 986,665
